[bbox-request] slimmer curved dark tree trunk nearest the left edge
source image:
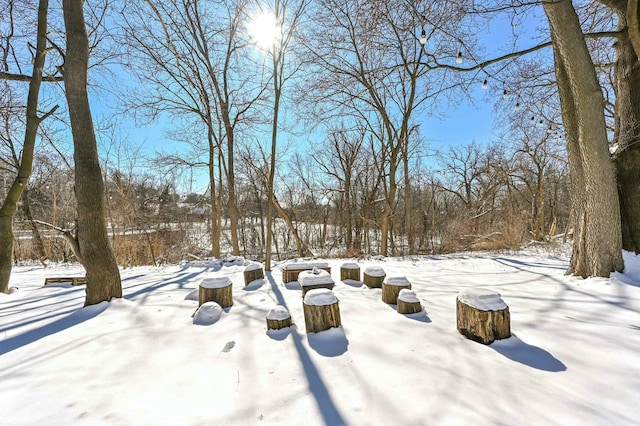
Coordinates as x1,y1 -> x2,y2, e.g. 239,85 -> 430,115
0,0 -> 50,293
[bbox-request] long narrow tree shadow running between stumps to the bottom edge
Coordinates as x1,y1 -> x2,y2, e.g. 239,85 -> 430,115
265,271 -> 346,425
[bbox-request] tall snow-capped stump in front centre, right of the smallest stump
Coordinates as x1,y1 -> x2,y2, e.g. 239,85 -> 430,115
302,288 -> 342,333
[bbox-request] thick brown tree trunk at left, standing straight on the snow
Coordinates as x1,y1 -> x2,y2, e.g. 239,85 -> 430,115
62,0 -> 122,306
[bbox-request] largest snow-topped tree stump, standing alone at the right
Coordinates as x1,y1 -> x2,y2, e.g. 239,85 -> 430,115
456,288 -> 511,345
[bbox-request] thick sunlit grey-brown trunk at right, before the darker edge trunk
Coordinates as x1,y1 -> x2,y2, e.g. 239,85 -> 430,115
543,0 -> 624,277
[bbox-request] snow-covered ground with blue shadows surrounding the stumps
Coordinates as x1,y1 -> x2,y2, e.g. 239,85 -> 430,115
0,248 -> 640,425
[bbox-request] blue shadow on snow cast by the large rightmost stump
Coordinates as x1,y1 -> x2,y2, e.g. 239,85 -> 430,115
490,334 -> 567,373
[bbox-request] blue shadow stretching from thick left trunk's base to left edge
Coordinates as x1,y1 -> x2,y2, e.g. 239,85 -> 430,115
0,302 -> 109,355
